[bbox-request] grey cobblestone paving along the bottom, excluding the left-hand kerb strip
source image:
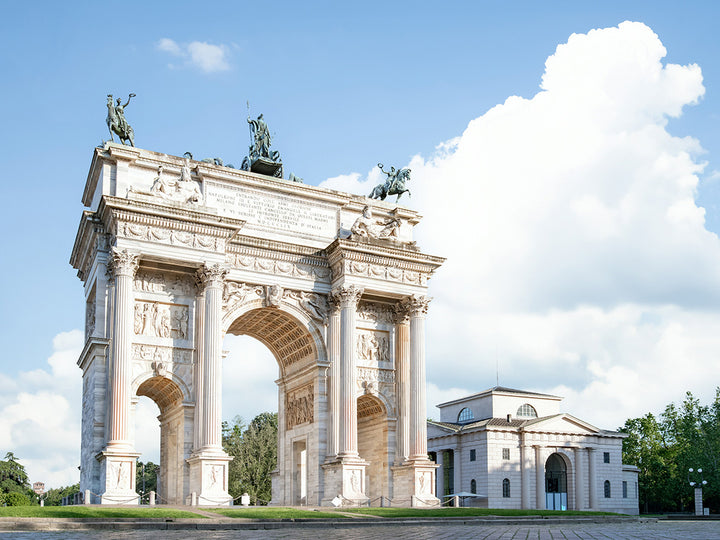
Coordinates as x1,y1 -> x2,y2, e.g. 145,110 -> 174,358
0,521 -> 720,540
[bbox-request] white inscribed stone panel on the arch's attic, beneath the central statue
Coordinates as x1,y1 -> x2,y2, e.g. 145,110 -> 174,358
205,180 -> 337,238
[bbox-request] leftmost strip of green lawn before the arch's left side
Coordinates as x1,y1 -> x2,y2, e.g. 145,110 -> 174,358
0,506 -> 205,519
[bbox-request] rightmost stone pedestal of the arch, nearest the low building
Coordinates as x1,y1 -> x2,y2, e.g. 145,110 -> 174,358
391,459 -> 440,508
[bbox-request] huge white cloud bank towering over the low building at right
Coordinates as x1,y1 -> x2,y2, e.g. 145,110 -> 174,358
322,22 -> 720,428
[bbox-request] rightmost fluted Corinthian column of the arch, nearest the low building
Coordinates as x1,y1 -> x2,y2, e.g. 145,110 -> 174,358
405,295 -> 431,460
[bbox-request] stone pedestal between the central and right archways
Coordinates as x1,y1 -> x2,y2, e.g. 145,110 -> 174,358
320,457 -> 370,506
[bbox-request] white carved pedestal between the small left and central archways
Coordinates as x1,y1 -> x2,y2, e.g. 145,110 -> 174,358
185,449 -> 233,506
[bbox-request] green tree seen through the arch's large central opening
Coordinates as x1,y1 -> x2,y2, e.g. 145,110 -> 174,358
223,413 -> 278,504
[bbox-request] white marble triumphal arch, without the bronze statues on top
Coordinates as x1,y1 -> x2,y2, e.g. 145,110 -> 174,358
71,142 -> 443,506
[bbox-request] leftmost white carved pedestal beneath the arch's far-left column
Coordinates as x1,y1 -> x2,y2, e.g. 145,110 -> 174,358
95,446 -> 140,505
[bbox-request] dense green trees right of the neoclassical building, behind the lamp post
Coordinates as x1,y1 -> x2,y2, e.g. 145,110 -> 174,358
621,388 -> 720,512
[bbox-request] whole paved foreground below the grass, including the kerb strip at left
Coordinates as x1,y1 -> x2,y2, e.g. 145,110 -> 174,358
0,517 -> 720,540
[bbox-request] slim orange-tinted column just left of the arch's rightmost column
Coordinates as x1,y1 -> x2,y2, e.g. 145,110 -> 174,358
395,302 -> 410,464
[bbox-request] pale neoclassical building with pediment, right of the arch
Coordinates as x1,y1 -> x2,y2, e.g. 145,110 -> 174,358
428,386 -> 639,514
